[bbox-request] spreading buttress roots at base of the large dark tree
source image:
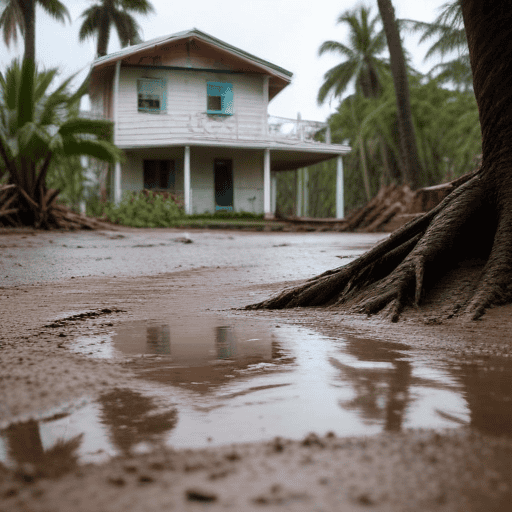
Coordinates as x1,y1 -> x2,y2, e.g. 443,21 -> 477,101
247,168 -> 512,321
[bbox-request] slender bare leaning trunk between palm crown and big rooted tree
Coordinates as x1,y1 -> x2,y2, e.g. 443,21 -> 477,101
377,0 -> 420,190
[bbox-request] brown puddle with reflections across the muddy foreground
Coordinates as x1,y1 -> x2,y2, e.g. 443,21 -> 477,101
0,316 -> 512,466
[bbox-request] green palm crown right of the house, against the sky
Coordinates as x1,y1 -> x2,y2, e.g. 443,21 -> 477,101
318,6 -> 388,104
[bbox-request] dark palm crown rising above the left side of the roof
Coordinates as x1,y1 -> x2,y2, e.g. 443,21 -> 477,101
78,0 -> 154,57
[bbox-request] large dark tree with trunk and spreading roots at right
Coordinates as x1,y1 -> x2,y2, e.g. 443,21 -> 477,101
249,0 -> 512,321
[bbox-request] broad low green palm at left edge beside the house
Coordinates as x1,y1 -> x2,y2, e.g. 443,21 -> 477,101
0,60 -> 121,227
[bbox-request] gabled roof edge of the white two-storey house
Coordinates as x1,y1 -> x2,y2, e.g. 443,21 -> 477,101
91,28 -> 293,97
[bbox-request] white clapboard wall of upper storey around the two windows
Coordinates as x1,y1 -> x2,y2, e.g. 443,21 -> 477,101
117,67 -> 267,146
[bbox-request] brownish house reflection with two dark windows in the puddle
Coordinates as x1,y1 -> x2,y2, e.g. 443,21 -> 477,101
108,317 -> 294,393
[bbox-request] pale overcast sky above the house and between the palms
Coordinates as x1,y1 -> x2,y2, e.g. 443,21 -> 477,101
0,0 -> 446,121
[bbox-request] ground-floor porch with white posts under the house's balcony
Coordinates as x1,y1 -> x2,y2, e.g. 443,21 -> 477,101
112,141 -> 349,218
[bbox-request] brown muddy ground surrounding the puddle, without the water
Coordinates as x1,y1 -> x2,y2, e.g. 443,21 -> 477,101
0,229 -> 512,512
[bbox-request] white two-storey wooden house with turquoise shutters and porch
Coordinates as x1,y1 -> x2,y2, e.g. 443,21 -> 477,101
89,29 -> 350,217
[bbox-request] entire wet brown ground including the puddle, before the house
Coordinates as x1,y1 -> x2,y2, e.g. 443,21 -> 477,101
0,230 -> 512,510
